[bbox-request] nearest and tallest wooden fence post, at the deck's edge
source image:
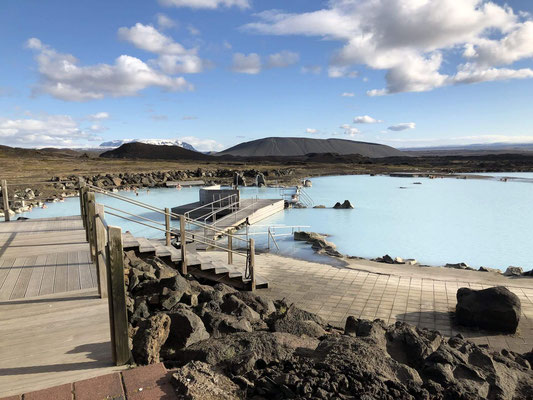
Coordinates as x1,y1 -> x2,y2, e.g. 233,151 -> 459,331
107,226 -> 131,365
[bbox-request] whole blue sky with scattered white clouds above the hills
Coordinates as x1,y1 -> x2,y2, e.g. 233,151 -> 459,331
0,0 -> 533,151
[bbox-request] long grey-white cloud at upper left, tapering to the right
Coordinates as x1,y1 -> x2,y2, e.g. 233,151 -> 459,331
27,38 -> 193,101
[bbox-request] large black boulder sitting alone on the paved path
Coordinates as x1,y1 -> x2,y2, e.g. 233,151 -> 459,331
455,286 -> 521,333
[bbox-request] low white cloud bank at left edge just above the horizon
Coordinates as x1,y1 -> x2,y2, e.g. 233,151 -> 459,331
0,115 -> 105,147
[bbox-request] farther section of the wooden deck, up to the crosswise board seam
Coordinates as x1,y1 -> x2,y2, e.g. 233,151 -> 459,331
0,217 -> 97,301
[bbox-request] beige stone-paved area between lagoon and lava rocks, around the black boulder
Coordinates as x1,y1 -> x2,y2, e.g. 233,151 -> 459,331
208,253 -> 533,353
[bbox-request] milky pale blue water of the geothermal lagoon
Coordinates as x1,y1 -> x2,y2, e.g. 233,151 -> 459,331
8,174 -> 533,270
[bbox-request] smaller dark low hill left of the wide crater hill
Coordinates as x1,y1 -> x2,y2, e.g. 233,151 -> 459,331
100,142 -> 214,160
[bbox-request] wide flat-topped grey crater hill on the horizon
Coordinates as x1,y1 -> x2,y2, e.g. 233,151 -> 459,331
217,137 -> 408,158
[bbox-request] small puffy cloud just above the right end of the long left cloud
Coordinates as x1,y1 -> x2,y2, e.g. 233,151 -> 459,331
118,23 -> 204,75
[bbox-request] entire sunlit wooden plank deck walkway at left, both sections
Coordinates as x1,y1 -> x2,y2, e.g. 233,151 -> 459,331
0,216 -> 117,397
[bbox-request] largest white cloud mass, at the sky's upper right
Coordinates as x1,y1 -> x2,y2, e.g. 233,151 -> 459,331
244,0 -> 533,96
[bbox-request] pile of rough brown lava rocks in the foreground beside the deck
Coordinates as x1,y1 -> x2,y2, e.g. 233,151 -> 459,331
125,251 -> 533,400
